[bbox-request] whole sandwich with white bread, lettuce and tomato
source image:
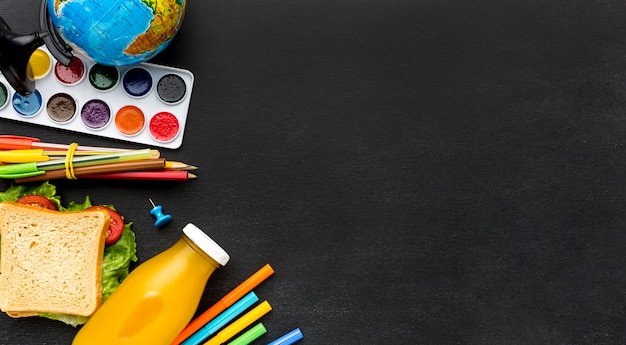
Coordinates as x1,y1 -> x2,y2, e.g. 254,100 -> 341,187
0,182 -> 137,326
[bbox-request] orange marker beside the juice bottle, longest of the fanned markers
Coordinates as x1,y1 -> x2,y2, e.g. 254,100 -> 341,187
171,264 -> 274,345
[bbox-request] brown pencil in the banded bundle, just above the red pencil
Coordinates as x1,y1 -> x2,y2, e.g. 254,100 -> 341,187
15,158 -> 165,183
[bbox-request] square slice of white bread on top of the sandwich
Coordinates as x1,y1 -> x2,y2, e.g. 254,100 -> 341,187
0,202 -> 110,317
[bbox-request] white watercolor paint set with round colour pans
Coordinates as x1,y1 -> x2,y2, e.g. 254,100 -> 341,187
0,48 -> 194,149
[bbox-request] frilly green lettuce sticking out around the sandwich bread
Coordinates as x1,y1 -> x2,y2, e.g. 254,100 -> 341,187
0,181 -> 137,327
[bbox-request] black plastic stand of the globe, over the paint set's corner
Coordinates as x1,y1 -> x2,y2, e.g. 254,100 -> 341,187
0,0 -> 72,96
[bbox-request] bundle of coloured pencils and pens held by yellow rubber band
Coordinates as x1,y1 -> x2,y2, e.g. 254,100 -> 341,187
0,135 -> 196,183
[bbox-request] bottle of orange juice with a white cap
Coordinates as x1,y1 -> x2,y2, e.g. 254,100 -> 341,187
72,224 -> 230,345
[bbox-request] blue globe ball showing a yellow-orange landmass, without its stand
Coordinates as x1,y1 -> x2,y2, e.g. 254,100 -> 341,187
47,0 -> 185,66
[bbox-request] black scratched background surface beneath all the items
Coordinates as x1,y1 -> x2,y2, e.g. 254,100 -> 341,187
0,0 -> 626,345
